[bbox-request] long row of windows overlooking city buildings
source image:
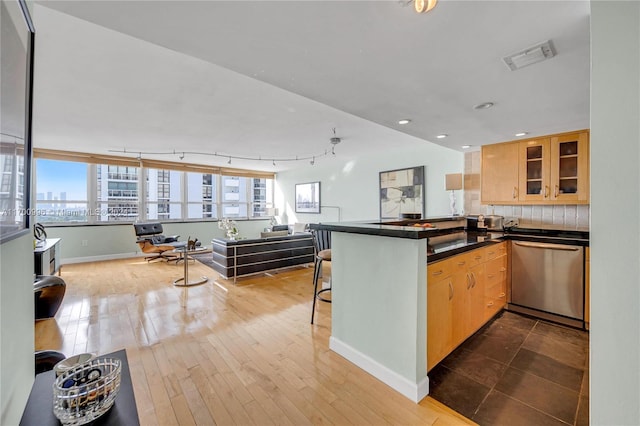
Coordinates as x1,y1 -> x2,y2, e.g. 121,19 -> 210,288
33,150 -> 273,223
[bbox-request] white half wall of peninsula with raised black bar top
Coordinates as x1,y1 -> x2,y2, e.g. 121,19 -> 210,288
314,217 -> 496,402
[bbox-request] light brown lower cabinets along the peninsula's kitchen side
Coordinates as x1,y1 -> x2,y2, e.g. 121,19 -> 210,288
427,242 -> 508,370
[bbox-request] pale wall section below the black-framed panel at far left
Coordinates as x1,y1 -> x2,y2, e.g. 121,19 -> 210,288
0,234 -> 34,425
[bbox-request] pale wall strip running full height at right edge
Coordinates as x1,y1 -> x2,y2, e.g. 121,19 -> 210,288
590,1 -> 640,425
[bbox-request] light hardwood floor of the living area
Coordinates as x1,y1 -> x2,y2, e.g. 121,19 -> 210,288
35,259 -> 473,425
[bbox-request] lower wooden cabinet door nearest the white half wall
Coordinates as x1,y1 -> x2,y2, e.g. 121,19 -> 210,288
427,277 -> 454,371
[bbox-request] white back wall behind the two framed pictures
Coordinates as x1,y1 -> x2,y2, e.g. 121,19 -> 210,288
275,141 -> 464,224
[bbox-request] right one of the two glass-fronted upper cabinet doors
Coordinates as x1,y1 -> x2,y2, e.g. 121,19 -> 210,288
550,132 -> 589,204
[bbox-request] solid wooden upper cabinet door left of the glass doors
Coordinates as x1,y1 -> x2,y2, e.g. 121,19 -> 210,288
480,143 -> 519,204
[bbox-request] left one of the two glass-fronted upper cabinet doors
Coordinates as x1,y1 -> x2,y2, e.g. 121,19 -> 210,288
519,139 -> 551,202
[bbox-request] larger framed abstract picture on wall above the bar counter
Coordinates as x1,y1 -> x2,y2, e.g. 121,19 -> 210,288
380,166 -> 425,219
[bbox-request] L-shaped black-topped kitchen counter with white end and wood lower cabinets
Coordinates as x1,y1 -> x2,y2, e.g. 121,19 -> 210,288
312,217 -> 589,402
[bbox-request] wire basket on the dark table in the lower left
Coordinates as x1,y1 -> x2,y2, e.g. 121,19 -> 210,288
53,358 -> 122,425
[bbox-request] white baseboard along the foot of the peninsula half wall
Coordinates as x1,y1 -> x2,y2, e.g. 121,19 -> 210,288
329,336 -> 429,403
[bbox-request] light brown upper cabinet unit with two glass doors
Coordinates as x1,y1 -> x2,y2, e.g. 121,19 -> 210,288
481,130 -> 589,204
